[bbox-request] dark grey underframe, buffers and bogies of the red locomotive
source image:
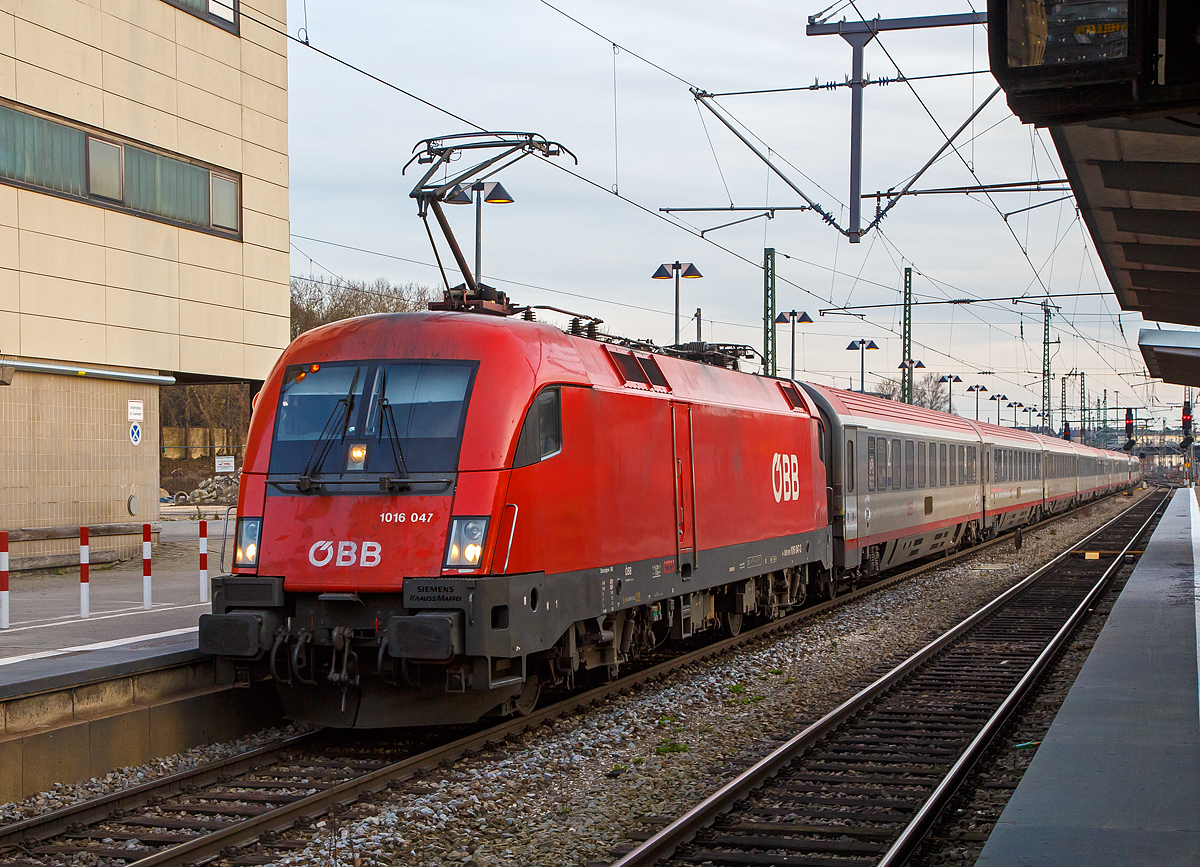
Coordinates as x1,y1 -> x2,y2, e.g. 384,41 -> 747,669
199,537 -> 832,728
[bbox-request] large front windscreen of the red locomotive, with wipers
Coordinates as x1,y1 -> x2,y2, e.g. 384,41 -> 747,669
270,360 -> 476,476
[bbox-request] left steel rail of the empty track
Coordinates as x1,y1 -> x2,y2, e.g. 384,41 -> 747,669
611,485 -> 1169,867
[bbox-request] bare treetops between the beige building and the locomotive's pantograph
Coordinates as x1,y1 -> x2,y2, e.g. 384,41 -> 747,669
292,277 -> 434,339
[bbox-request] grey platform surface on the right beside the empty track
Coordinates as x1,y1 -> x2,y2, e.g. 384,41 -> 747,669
976,489 -> 1200,867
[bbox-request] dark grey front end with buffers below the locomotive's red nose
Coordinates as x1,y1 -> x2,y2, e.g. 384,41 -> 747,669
199,575 -> 538,728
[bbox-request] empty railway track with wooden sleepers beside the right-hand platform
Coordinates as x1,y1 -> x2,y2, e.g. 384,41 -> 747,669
613,485 -> 1170,867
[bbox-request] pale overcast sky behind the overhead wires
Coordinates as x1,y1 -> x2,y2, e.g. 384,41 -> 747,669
274,0 -> 1182,426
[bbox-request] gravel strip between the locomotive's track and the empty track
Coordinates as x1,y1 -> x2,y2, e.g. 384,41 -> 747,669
241,489 -> 1132,867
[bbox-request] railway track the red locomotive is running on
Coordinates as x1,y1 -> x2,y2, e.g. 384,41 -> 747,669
0,489 -> 1147,867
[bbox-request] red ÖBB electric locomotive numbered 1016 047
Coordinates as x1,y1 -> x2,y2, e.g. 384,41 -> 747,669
199,312 -> 835,728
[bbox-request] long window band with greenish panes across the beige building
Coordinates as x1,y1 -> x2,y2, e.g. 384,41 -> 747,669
0,106 -> 241,234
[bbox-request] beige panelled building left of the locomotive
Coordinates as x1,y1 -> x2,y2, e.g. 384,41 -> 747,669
0,0 -> 289,564
